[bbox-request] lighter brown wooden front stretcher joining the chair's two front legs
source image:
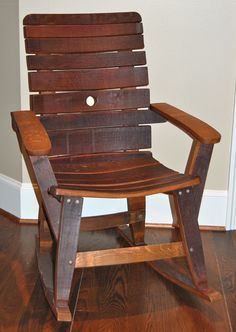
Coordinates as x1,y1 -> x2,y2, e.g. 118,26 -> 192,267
75,242 -> 185,268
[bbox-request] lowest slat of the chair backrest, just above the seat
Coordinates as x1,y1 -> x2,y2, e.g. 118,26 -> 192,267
49,126 -> 151,155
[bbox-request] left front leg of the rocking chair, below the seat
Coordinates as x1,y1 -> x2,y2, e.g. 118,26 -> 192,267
54,196 -> 83,321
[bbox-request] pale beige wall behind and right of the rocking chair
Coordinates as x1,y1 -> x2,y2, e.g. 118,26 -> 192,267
19,0 -> 236,190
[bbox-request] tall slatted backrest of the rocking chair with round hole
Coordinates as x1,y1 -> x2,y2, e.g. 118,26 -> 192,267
24,12 -> 163,155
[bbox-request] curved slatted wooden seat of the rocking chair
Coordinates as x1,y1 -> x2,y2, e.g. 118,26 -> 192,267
50,151 -> 200,198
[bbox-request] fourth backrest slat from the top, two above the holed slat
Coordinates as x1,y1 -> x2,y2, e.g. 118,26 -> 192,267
27,51 -> 146,70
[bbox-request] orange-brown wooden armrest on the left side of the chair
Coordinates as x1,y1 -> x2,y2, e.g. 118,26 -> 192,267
11,111 -> 51,156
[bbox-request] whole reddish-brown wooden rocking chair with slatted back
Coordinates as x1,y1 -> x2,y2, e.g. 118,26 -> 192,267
12,12 -> 220,321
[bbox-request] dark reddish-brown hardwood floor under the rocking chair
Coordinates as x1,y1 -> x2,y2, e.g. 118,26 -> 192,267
0,217 -> 236,332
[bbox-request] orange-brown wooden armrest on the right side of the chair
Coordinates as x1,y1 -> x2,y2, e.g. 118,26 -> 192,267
150,103 -> 221,144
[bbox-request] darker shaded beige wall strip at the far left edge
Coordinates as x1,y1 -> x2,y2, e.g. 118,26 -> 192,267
0,0 -> 22,181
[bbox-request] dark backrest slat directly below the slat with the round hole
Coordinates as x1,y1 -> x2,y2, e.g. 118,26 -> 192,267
40,110 -> 164,131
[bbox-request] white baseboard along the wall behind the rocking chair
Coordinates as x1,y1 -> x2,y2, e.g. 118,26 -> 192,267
0,174 -> 227,227
